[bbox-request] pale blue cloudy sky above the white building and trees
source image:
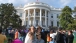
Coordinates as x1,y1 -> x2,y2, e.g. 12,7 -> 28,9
0,0 -> 76,9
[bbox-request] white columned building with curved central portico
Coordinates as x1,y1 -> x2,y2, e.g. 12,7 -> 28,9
16,2 -> 61,28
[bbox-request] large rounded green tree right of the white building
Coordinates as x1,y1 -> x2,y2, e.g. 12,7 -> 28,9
59,6 -> 73,29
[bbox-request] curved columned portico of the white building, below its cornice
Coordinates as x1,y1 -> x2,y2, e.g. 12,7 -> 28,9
24,8 -> 48,27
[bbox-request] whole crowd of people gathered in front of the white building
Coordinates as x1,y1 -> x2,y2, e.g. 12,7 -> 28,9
0,26 -> 74,43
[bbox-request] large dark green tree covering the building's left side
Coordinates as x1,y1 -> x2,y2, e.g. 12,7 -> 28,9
0,3 -> 22,28
